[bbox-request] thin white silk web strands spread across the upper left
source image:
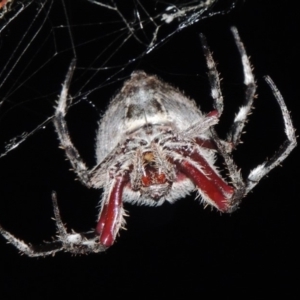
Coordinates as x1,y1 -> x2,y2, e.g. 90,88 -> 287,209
0,0 -> 239,158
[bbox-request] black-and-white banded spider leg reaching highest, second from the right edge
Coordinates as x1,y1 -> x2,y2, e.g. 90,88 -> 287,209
227,27 -> 256,150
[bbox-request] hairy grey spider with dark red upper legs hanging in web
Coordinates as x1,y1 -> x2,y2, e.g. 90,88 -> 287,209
0,27 -> 296,256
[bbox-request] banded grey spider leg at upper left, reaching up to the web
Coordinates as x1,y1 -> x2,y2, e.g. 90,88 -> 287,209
53,60 -> 91,187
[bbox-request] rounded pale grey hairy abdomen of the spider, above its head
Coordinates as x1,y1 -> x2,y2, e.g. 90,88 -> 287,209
96,71 -> 203,162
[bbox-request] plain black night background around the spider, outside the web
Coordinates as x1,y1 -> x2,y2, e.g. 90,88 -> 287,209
0,0 -> 300,299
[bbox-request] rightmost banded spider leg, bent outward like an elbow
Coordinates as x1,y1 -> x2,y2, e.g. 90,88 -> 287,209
246,76 -> 297,193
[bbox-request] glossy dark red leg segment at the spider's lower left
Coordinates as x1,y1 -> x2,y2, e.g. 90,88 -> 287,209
96,175 -> 129,247
